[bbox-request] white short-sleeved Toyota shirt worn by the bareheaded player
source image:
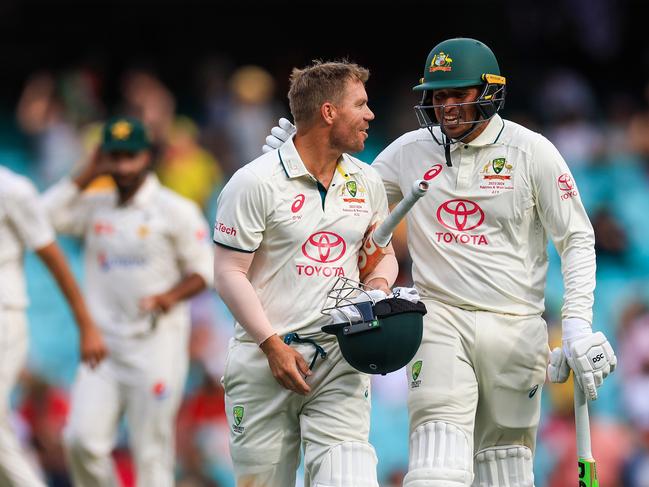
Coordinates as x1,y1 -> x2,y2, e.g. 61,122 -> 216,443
214,133 -> 387,341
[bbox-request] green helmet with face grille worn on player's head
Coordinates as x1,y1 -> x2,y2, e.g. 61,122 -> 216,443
413,38 -> 506,160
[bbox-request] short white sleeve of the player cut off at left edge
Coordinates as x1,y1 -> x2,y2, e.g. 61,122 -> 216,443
4,176 -> 56,250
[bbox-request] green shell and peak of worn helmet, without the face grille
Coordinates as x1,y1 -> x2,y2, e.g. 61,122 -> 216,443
413,37 -> 505,91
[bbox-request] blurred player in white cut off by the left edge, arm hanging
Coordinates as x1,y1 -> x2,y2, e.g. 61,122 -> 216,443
0,166 -> 106,487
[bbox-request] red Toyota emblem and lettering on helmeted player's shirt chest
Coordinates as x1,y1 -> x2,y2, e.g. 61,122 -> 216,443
435,199 -> 489,245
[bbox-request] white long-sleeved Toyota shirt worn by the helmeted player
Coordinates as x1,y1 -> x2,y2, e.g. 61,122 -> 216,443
372,115 -> 595,322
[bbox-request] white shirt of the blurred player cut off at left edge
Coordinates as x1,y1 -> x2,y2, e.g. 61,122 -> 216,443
0,166 -> 55,309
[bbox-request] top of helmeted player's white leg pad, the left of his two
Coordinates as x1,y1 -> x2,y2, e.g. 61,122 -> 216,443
403,421 -> 473,487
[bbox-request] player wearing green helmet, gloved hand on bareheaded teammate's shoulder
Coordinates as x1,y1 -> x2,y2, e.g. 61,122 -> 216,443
265,38 -> 617,487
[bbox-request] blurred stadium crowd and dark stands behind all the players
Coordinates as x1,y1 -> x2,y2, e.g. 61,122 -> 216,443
0,0 -> 649,487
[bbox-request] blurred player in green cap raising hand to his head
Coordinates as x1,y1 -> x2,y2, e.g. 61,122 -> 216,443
43,117 -> 212,487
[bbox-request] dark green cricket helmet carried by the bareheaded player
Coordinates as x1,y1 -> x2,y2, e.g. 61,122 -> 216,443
322,277 -> 426,375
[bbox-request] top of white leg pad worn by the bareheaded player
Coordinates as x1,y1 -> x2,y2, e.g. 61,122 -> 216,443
311,441 -> 379,487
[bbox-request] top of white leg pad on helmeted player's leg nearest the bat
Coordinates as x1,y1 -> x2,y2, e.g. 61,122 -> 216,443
473,445 -> 534,487
